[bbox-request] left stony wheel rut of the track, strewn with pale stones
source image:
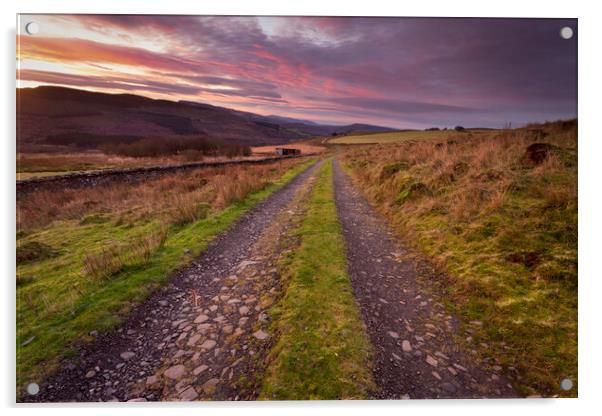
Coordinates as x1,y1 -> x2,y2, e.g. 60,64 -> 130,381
25,163 -> 320,402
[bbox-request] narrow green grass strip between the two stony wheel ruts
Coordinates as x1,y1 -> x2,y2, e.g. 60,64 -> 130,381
260,161 -> 374,400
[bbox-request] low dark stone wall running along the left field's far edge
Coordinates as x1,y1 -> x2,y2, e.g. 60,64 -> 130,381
17,154 -> 314,195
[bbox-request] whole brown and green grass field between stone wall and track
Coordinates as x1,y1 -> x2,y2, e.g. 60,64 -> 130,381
16,159 -> 312,383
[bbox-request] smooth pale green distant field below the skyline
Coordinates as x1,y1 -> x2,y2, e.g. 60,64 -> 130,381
327,129 -> 490,144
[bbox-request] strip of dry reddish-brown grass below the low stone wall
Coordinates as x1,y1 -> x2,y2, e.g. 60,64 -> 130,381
17,160 -> 301,232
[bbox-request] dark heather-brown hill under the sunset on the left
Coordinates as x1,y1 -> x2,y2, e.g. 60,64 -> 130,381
17,86 -> 392,152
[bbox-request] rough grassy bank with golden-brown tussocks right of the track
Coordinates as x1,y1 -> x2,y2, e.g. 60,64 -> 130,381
343,121 -> 577,396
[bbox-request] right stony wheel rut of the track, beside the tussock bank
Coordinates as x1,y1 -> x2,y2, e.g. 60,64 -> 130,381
334,160 -> 517,399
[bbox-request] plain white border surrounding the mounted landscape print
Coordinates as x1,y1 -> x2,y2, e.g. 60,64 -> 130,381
0,0 -> 602,416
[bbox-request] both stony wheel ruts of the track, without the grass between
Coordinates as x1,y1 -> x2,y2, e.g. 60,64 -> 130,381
24,161 -> 517,402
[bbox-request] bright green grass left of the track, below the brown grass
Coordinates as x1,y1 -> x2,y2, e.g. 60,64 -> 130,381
17,161 -> 314,390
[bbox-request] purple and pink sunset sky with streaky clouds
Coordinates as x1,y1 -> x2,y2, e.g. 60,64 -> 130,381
17,15 -> 577,128
